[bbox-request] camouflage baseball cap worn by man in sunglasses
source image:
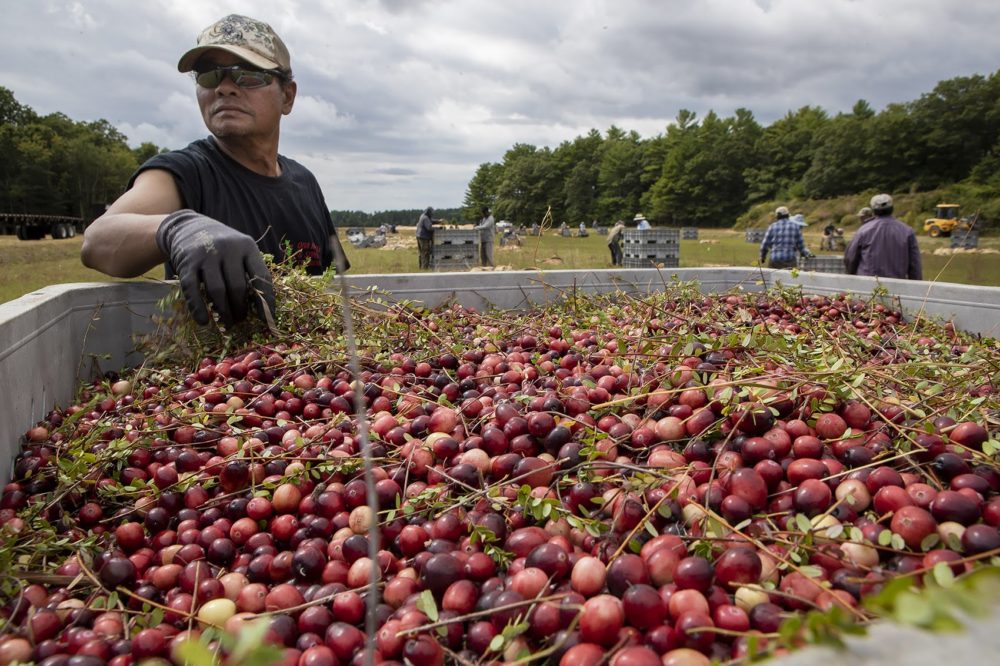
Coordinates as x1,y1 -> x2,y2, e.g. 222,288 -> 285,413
177,14 -> 292,76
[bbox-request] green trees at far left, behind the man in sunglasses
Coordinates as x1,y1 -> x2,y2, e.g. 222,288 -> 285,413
0,87 -> 166,218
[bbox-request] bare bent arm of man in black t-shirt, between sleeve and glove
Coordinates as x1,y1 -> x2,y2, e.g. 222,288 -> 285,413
80,169 -> 183,278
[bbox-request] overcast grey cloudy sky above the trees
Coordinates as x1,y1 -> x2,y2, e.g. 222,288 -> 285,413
0,0 -> 1000,211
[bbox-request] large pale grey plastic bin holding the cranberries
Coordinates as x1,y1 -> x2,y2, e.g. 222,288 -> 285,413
0,268 -> 1000,666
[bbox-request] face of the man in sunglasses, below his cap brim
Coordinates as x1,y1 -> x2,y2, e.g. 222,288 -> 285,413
196,51 -> 296,138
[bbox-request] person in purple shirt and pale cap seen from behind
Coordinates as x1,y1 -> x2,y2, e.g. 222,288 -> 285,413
844,194 -> 923,280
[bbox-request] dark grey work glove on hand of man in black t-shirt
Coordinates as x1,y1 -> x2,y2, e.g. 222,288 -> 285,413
156,210 -> 274,326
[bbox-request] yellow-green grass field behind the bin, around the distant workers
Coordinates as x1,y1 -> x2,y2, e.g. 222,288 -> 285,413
0,228 -> 1000,302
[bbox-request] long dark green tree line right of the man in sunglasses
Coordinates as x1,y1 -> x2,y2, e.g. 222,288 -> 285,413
463,72 -> 1000,227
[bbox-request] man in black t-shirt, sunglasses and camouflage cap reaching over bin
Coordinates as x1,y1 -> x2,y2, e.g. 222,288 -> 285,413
81,14 -> 348,325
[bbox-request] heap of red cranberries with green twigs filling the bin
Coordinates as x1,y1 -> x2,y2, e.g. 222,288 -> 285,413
0,292 -> 1000,666
